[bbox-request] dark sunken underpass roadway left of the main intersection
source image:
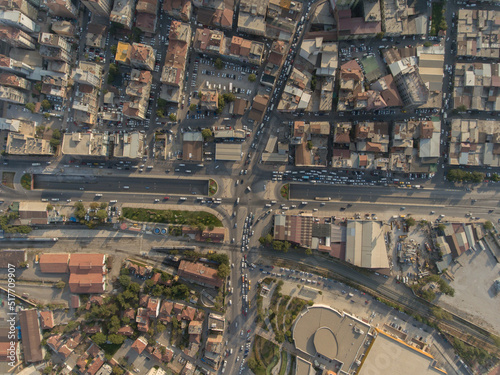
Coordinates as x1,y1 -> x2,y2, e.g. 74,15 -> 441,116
33,174 -> 208,195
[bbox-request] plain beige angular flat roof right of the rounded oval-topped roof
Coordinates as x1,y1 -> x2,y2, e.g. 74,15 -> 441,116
358,330 -> 446,375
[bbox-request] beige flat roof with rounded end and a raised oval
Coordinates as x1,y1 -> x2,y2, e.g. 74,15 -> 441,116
293,305 -> 370,371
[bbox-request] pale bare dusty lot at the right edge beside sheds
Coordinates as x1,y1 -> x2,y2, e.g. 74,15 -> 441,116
438,250 -> 500,334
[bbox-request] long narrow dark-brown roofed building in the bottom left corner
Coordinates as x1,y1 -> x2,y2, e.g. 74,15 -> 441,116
18,309 -> 45,363
